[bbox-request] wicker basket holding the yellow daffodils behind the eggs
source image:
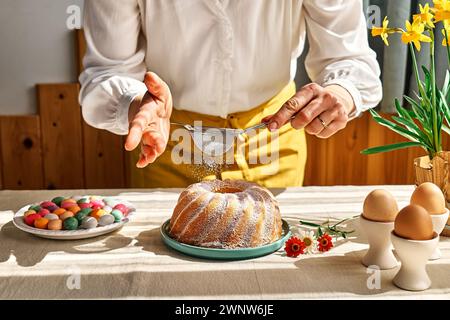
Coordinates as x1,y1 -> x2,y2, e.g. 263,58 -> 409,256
414,151 -> 450,237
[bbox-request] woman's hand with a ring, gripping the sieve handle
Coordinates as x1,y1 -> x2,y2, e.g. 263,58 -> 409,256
263,83 -> 355,138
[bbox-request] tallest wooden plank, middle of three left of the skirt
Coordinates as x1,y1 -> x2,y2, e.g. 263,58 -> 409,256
37,84 -> 85,189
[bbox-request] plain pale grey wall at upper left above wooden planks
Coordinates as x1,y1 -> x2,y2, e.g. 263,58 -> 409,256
0,0 -> 83,115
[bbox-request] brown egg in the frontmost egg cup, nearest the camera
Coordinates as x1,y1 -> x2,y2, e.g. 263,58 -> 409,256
394,205 -> 434,240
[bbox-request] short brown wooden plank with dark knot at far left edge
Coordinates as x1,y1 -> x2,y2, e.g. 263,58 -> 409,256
0,116 -> 44,190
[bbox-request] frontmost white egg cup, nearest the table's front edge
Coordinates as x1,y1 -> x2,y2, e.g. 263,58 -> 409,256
391,232 -> 439,291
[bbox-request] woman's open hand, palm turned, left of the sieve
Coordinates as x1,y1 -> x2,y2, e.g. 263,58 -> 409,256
125,72 -> 172,168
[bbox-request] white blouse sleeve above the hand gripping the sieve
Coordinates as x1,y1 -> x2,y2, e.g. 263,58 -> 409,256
304,0 -> 382,116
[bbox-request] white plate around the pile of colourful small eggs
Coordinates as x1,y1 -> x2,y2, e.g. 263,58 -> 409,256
13,197 -> 136,240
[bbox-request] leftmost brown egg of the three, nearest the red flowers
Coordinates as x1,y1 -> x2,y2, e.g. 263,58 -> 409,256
363,189 -> 398,222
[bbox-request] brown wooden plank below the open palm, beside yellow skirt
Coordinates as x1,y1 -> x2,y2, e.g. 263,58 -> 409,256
83,123 -> 125,189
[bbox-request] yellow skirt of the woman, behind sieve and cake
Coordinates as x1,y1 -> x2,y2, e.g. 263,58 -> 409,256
129,82 -> 307,188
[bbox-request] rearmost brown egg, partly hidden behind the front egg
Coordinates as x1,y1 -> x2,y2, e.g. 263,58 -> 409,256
411,182 -> 446,214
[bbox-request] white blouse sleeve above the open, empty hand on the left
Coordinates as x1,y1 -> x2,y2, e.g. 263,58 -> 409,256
79,0 -> 147,135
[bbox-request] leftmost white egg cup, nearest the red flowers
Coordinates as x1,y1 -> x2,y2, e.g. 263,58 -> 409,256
359,215 -> 398,270
